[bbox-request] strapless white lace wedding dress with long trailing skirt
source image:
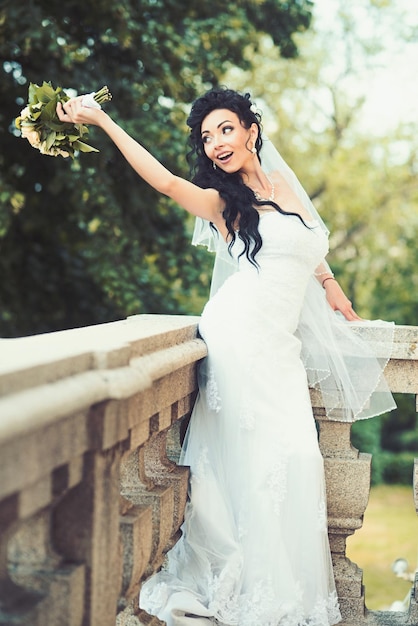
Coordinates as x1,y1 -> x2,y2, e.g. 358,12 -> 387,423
140,211 -> 341,626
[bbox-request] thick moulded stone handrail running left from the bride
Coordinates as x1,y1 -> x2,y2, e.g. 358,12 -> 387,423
0,315 -> 205,444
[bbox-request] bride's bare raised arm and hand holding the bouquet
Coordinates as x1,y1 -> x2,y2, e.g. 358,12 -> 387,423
57,97 -> 225,231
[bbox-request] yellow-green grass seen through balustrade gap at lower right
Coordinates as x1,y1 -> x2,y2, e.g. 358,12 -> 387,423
347,485 -> 418,611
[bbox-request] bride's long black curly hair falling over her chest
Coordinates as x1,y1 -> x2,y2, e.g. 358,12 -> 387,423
187,87 -> 298,266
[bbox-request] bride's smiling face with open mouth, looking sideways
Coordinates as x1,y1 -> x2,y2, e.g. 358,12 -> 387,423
201,109 -> 258,173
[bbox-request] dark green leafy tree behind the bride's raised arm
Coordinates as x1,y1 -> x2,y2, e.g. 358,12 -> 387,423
0,0 -> 312,336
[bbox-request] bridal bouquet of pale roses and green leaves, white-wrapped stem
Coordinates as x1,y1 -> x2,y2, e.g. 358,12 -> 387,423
15,82 -> 112,159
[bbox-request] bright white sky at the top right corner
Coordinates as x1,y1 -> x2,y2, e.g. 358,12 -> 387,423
314,0 -> 418,133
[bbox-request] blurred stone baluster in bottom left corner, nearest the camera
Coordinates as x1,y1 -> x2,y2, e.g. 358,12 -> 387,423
0,442 -> 85,626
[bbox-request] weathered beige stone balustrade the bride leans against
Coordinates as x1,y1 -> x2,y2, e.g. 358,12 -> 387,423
0,315 -> 418,626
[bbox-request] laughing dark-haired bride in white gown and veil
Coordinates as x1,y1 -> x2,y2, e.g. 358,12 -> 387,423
58,88 -> 393,626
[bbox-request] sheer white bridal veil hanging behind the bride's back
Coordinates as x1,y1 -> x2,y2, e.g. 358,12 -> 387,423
192,136 -> 396,422
